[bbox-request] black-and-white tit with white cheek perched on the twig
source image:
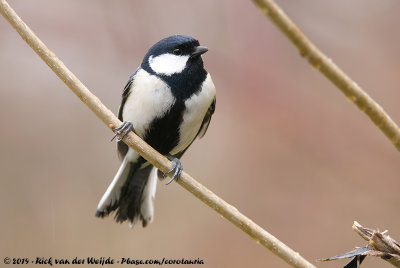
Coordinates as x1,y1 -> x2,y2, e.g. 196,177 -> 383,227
95,35 -> 216,227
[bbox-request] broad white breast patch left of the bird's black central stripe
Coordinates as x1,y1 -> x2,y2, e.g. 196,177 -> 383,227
122,69 -> 175,138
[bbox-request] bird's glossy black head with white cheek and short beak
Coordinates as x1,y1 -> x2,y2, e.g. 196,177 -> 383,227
141,35 -> 208,99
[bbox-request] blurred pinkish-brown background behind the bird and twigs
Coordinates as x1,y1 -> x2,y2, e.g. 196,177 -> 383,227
0,0 -> 400,267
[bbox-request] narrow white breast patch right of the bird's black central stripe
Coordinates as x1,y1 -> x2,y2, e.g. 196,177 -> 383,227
170,74 -> 216,155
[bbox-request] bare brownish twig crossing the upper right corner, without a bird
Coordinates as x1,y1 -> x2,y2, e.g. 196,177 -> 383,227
253,0 -> 400,151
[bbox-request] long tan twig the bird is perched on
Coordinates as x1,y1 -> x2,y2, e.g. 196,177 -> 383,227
0,0 -> 314,267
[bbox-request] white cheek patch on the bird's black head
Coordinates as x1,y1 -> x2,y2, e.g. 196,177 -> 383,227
149,53 -> 189,76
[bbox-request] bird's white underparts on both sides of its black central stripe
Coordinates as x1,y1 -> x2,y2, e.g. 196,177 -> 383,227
122,70 -> 216,161
